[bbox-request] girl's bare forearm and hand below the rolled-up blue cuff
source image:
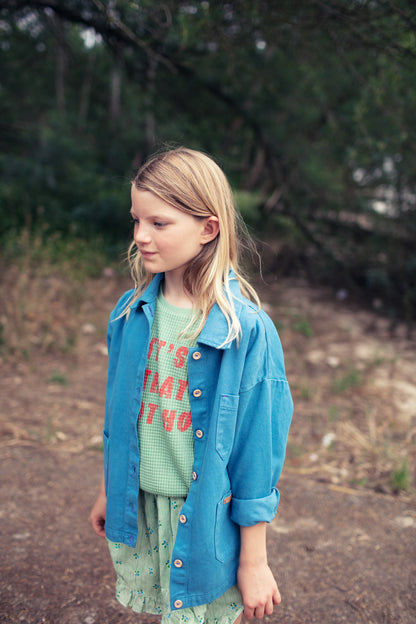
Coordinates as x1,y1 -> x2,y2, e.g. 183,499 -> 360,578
237,522 -> 282,620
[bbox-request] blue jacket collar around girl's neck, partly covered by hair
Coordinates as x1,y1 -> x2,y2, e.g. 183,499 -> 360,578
130,271 -> 243,349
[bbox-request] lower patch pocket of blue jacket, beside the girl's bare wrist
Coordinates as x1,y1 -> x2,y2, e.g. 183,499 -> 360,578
214,492 -> 240,563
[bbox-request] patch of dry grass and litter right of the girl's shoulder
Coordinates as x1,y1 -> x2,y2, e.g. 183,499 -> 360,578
263,281 -> 416,493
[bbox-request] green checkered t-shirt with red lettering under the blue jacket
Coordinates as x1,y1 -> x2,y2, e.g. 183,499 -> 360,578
137,290 -> 196,496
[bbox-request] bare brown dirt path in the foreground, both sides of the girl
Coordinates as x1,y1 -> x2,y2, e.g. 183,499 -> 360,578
0,443 -> 416,624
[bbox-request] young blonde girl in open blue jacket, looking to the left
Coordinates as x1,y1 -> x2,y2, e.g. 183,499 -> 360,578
90,148 -> 293,624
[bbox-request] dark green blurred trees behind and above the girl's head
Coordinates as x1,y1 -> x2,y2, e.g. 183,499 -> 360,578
0,0 -> 416,323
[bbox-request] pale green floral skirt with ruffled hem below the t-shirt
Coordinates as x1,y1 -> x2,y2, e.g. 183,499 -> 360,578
107,491 -> 243,624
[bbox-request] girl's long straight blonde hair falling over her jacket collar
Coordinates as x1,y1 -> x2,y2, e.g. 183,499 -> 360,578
128,147 -> 260,344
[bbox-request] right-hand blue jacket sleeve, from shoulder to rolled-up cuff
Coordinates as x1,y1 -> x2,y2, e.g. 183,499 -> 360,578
228,318 -> 293,526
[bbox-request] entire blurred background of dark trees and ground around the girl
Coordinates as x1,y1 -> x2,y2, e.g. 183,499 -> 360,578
0,0 -> 416,624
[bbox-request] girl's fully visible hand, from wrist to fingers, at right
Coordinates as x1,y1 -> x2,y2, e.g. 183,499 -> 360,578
237,563 -> 282,620
